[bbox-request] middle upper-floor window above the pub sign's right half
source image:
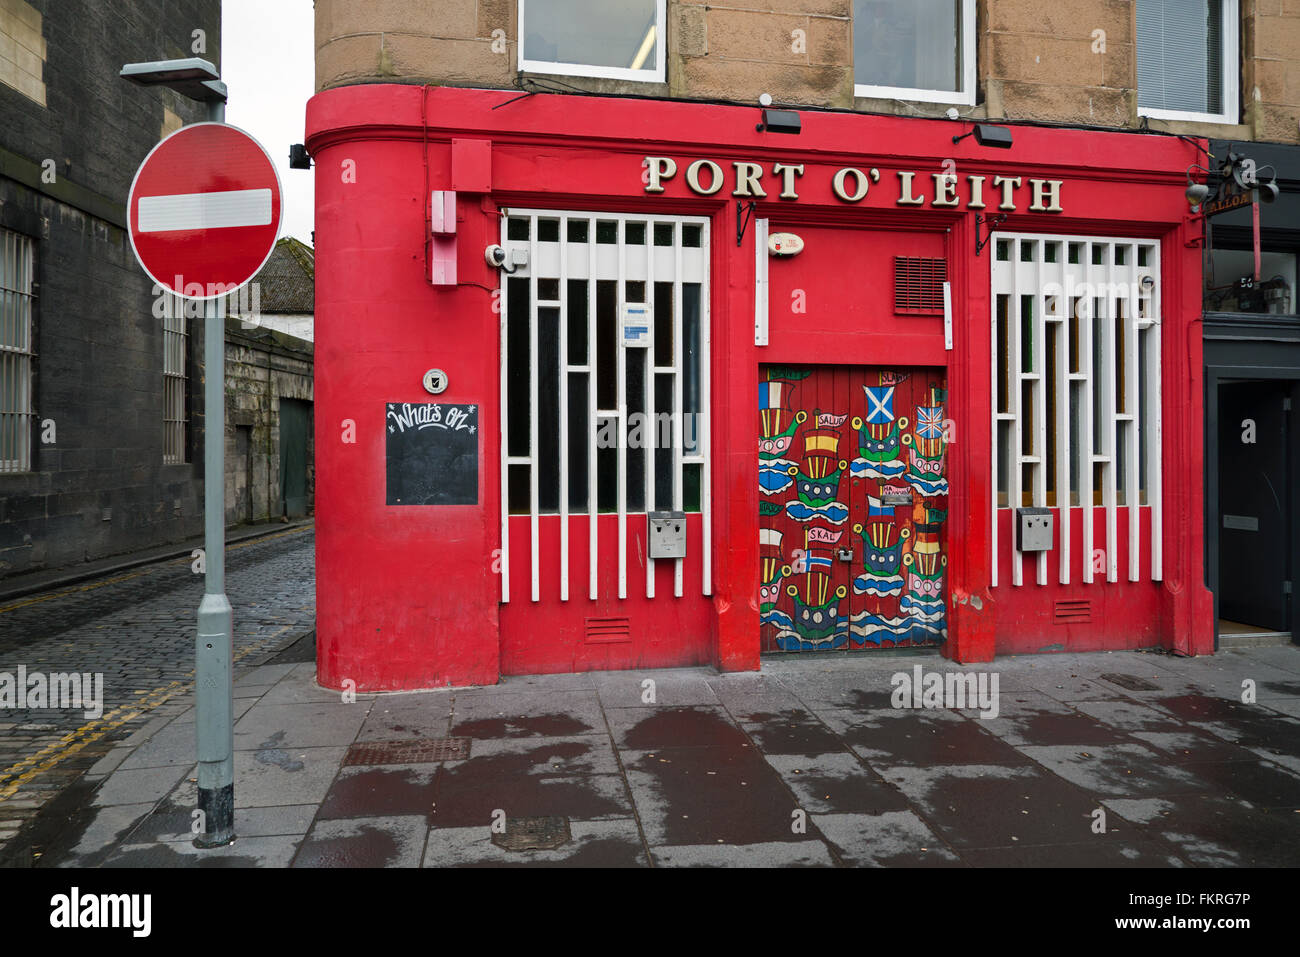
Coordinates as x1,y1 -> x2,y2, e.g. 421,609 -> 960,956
853,0 -> 975,104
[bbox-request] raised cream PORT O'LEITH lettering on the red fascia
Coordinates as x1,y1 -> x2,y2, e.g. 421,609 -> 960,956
641,156 -> 1065,213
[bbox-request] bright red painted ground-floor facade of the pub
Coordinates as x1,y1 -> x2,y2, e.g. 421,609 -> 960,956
307,85 -> 1213,690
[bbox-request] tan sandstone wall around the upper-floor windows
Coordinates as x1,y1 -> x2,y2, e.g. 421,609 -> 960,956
316,0 -> 1300,143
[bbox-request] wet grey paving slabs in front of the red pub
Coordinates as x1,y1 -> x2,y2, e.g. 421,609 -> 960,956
0,646 -> 1300,867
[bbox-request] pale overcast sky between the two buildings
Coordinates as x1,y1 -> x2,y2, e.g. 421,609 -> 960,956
221,0 -> 316,246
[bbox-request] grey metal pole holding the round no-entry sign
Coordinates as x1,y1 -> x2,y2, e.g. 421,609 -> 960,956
194,95 -> 235,848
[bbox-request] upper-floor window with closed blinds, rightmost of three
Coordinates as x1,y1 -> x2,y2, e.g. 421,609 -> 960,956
1138,0 -> 1239,124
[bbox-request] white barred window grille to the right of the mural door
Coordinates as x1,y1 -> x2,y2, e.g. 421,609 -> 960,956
991,233 -> 1161,585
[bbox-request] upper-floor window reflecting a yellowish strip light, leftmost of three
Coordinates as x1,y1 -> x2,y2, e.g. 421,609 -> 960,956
519,0 -> 666,83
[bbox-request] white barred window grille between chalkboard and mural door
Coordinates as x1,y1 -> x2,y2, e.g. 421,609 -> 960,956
501,209 -> 712,602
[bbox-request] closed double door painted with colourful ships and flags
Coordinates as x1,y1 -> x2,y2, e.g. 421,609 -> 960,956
758,367 -> 948,651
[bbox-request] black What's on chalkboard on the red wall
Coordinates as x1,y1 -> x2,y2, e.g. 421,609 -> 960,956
385,402 -> 478,505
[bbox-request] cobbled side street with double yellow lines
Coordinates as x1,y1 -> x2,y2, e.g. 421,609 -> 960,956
0,527 -> 316,846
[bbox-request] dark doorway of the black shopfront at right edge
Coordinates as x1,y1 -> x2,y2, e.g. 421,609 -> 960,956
1218,380 -> 1294,637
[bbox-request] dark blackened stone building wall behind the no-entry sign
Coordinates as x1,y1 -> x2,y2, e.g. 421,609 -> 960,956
0,0 -> 221,580
